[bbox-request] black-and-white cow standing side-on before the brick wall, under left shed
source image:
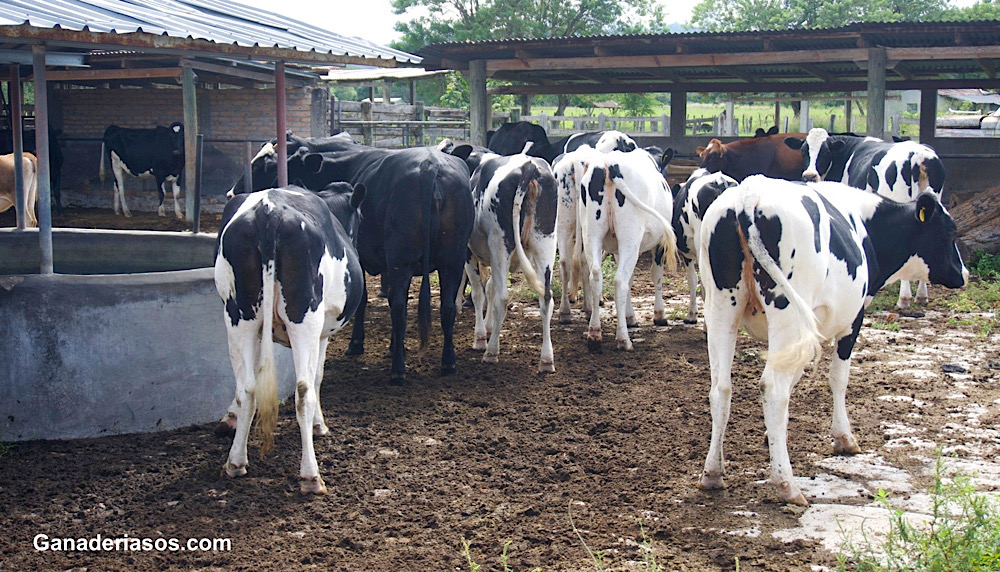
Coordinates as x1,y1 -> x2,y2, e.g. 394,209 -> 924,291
100,122 -> 184,218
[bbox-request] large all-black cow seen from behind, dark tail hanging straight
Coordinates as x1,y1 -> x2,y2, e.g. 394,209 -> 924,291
234,138 -> 475,384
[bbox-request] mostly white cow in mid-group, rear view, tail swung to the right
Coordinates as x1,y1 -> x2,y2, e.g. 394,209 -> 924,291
577,151 -> 677,351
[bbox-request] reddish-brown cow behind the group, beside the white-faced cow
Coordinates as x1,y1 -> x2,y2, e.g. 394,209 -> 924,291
697,133 -> 805,181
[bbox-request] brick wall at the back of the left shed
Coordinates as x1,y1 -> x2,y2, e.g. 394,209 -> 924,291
51,86 -> 329,211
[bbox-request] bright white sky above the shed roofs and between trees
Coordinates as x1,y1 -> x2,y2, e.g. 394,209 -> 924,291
236,0 -> 700,45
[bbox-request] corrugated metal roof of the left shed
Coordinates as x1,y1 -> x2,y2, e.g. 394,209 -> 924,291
0,0 -> 421,64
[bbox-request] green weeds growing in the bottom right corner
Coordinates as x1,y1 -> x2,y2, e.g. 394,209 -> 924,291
837,456 -> 1000,572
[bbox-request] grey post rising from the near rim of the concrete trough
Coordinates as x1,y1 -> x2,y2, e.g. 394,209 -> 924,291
31,44 -> 53,274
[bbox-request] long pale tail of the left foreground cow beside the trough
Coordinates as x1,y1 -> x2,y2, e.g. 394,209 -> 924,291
254,229 -> 278,458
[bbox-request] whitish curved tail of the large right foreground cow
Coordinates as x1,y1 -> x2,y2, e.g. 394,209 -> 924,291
741,193 -> 823,371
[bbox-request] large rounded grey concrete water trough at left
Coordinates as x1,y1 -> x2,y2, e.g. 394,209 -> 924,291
0,229 -> 294,441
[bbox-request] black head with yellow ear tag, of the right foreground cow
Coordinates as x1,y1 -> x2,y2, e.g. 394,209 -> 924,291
899,191 -> 969,288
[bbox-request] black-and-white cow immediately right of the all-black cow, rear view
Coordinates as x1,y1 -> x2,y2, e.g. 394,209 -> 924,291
465,153 -> 557,372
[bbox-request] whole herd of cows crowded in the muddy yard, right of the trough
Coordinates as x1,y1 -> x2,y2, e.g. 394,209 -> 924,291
207,123 -> 968,505
